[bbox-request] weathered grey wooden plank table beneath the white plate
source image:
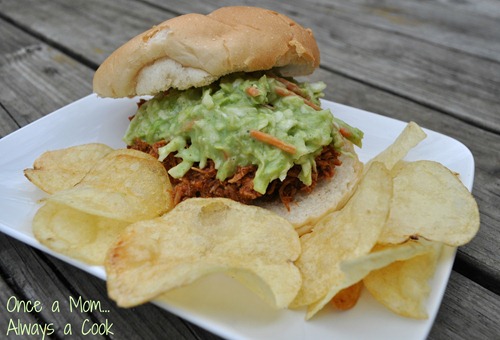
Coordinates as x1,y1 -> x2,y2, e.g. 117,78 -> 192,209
0,0 -> 500,339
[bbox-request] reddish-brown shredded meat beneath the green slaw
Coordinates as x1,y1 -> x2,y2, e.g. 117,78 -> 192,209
129,140 -> 341,209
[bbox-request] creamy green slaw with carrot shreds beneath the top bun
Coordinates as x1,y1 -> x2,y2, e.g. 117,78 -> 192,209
124,74 -> 363,194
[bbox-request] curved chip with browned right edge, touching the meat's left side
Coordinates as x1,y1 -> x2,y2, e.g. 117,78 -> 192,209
50,149 -> 173,222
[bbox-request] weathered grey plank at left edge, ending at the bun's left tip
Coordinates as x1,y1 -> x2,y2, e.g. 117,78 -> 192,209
0,22 -> 93,125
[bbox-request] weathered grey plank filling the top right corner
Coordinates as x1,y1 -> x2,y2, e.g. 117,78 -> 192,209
308,0 -> 500,61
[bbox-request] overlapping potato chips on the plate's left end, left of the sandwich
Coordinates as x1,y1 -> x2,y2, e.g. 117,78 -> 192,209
25,144 -> 173,265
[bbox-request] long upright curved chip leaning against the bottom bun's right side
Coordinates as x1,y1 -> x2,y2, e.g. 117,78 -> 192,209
292,163 -> 392,316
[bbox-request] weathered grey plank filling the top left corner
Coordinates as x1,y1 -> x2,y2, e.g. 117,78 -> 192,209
0,0 -> 177,67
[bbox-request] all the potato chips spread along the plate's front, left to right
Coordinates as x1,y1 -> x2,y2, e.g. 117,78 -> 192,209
25,123 -> 479,319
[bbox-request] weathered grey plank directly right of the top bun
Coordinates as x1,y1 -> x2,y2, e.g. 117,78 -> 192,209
318,14 -> 500,133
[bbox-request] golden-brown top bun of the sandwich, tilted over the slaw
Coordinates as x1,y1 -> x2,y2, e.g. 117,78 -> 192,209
93,6 -> 319,98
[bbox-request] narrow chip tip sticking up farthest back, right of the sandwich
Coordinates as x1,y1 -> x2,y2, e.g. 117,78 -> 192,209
368,122 -> 427,170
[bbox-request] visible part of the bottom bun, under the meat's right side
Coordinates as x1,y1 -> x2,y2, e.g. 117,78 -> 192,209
260,140 -> 363,235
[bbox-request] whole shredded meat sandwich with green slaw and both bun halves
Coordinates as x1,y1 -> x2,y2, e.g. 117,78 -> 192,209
93,6 -> 363,233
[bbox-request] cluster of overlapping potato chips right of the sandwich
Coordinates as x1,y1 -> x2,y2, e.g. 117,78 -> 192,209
292,123 -> 479,319
